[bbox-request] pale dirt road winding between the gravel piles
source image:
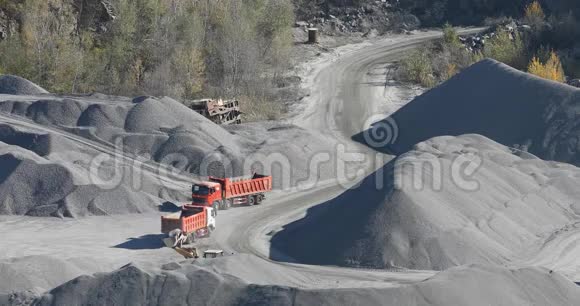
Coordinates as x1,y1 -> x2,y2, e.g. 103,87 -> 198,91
206,29 -> 492,288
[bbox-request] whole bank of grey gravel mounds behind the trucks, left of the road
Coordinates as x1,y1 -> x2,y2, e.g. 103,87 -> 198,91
0,77 -> 335,217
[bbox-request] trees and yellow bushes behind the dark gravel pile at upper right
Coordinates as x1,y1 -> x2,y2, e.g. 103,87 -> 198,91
397,0 -> 580,87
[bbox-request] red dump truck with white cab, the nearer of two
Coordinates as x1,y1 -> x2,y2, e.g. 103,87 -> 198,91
161,205 -> 215,246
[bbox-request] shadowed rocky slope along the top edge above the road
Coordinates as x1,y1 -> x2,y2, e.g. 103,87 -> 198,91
294,0 -> 580,32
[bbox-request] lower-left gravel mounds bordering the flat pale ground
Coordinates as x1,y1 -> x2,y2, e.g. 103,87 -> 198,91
0,142 -> 162,217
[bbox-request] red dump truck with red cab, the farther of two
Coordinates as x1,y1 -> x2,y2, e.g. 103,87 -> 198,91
191,174 -> 272,212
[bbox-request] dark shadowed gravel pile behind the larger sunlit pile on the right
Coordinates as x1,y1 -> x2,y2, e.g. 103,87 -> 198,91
355,59 -> 580,165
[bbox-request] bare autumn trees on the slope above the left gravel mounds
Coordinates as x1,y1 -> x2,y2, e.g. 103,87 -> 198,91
0,0 -> 294,118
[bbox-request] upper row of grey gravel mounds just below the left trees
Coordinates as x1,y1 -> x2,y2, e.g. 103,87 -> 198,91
0,97 -> 241,175
